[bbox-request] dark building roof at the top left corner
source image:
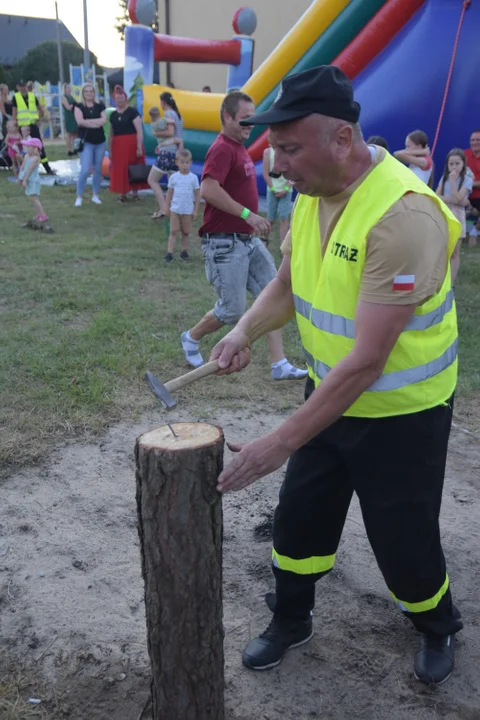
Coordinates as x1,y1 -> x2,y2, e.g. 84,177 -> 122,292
0,15 -> 81,66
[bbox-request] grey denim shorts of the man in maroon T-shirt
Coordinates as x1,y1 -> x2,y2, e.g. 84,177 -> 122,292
202,235 -> 277,325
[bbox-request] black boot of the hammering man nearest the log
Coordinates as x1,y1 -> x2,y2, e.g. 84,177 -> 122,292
243,615 -> 313,670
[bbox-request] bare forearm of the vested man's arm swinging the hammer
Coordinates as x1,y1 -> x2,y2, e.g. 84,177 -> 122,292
237,276 -> 295,343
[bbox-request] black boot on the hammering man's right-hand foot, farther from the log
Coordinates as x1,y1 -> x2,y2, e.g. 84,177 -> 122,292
413,633 -> 455,685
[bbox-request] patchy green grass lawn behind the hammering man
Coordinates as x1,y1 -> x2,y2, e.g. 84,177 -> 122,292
0,145 -> 480,470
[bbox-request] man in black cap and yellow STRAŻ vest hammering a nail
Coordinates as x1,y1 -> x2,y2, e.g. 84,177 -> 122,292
211,66 -> 462,684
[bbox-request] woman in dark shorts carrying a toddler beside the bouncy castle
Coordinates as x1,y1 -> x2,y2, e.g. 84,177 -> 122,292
148,92 -> 183,219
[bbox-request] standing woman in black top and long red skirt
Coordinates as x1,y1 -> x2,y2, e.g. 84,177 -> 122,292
108,85 -> 148,203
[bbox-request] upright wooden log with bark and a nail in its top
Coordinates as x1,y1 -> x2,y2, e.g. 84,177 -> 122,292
135,423 -> 224,720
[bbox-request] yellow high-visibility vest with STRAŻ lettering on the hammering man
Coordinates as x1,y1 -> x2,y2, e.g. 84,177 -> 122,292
291,153 -> 461,417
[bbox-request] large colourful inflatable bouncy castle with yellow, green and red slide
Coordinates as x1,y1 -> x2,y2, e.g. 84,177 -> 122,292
124,0 -> 480,192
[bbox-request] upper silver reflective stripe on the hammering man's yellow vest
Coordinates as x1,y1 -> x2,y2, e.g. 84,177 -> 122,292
293,289 -> 454,340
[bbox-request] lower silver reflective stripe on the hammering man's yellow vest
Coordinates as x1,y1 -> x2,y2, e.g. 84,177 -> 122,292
303,339 -> 458,392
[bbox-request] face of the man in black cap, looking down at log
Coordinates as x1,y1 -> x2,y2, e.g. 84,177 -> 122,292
270,114 -> 352,197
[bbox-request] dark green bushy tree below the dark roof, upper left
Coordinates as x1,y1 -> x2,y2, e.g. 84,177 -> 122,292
11,40 -> 99,84
